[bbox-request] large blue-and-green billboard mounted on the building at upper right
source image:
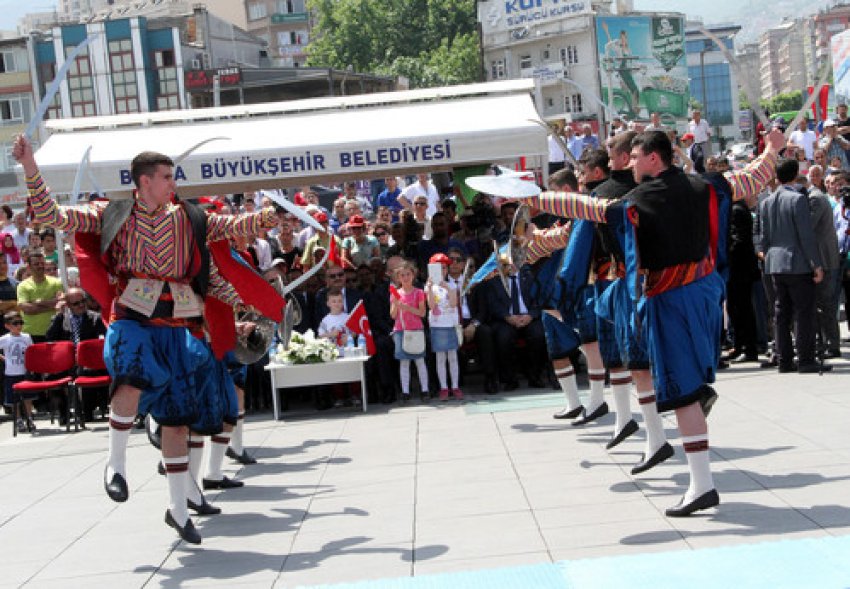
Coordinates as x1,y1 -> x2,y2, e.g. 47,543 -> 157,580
596,15 -> 689,121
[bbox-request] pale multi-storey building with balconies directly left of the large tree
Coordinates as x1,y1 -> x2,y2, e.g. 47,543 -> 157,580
244,0 -> 313,67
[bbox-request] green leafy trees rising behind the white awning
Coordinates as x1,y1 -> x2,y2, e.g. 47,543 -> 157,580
307,0 -> 483,88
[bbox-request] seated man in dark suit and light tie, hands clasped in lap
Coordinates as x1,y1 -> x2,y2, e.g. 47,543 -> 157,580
482,266 -> 546,391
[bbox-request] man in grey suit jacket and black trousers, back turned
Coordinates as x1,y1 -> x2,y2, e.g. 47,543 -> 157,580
756,159 -> 820,372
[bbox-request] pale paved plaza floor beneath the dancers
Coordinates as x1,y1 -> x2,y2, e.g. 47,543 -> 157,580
0,350 -> 850,589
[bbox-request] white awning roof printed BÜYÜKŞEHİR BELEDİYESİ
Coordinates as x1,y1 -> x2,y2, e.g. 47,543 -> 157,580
29,81 -> 547,196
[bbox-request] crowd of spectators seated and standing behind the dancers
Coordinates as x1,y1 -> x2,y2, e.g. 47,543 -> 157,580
6,106 -> 850,420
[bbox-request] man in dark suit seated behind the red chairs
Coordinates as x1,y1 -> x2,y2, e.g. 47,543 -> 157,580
45,288 -> 109,424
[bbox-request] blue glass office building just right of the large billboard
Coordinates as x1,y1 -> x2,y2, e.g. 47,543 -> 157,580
685,25 -> 741,142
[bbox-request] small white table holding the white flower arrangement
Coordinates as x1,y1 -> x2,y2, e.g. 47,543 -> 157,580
266,356 -> 369,421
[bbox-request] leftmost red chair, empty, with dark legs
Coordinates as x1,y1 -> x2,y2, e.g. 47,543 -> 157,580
12,342 -> 79,436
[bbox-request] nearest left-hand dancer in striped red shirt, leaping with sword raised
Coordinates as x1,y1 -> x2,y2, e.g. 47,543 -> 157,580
13,136 -> 276,544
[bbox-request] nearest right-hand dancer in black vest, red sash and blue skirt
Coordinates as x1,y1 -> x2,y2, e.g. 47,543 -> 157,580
527,131 -> 784,517
